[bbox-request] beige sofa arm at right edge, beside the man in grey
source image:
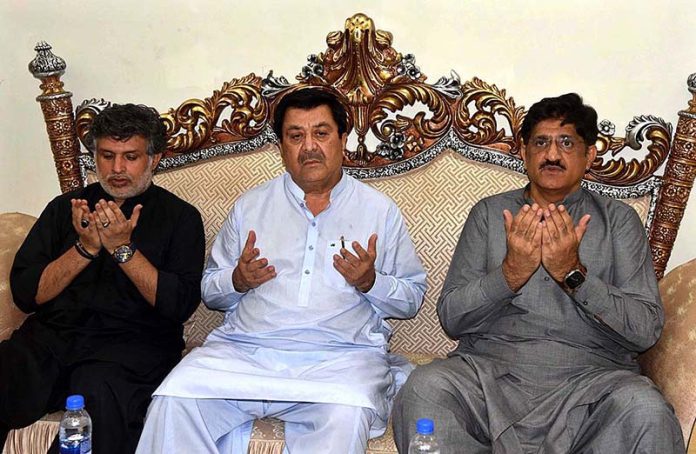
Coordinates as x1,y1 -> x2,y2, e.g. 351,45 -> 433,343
640,259 -> 696,440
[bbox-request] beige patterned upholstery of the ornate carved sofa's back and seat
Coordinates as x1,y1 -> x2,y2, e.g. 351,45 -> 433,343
0,146 -> 693,454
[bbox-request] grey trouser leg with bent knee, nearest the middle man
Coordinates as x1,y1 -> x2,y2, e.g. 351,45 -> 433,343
392,357 -> 491,454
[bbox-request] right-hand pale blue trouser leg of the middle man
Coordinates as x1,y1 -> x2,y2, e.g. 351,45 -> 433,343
267,402 -> 376,454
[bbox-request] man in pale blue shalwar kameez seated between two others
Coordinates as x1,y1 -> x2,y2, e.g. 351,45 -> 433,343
137,89 -> 425,454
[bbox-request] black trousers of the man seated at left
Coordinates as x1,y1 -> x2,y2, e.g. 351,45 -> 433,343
0,324 -> 178,454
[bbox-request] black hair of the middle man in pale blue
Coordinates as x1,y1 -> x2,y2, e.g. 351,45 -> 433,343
273,88 -> 348,142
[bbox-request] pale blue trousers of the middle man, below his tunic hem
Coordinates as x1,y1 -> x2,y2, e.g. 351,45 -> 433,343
136,396 -> 375,454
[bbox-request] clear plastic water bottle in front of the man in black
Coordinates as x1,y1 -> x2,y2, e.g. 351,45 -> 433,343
58,394 -> 92,454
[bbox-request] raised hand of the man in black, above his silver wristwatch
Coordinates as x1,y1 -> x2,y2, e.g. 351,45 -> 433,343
94,199 -> 143,254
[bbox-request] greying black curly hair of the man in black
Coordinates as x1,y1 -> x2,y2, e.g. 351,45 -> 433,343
85,104 -> 167,156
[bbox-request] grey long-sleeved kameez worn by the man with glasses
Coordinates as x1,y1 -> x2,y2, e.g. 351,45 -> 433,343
438,189 -> 680,452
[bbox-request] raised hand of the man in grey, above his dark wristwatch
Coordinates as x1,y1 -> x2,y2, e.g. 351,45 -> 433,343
541,203 -> 590,282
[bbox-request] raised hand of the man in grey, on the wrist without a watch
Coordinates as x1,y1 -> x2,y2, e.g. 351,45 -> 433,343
503,203 -> 544,292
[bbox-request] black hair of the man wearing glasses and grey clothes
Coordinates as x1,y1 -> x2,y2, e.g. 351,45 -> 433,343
520,93 -> 599,146
